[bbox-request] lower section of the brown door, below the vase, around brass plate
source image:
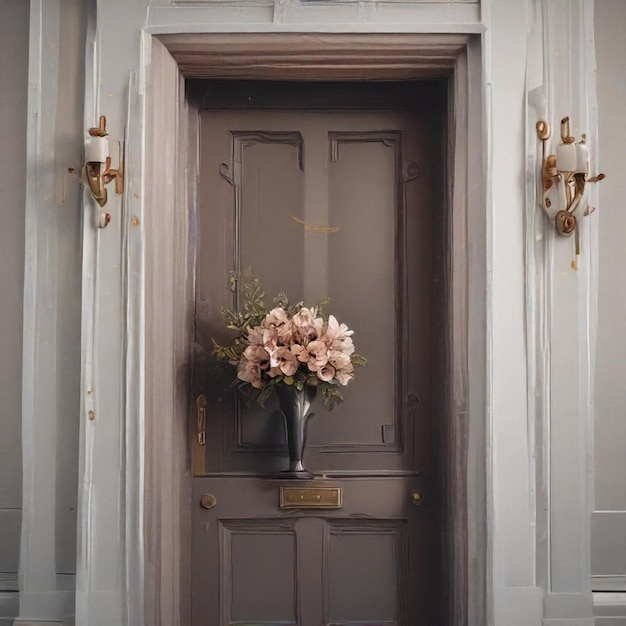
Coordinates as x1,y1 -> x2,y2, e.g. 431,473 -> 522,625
192,476 -> 428,626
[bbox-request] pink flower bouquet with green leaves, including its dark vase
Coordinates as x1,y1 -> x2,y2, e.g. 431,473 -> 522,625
213,279 -> 366,478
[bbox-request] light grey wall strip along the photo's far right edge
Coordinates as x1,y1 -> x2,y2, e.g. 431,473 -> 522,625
592,0 -> 626,590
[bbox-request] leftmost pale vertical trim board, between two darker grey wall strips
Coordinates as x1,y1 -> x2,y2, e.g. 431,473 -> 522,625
19,0 -> 56,590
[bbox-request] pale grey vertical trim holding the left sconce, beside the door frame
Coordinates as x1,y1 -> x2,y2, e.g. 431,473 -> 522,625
76,0 -> 145,625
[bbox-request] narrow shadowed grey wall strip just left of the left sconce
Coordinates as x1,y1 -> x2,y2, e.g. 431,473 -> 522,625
51,0 -> 87,574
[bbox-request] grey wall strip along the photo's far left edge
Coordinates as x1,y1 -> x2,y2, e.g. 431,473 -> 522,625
0,0 -> 29,596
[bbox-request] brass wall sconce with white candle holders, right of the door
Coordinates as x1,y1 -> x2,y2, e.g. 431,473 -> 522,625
536,117 -> 604,254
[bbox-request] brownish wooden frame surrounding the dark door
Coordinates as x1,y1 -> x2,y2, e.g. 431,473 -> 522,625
144,33 -> 491,626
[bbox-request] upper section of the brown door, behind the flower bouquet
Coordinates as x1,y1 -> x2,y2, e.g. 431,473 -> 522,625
196,111 -> 435,472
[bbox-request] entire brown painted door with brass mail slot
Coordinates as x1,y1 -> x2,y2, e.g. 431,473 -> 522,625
191,86 -> 443,626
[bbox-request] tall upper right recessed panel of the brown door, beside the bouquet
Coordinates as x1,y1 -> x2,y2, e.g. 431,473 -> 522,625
322,132 -> 394,452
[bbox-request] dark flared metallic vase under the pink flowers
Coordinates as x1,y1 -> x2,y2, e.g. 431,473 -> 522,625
276,385 -> 317,479
